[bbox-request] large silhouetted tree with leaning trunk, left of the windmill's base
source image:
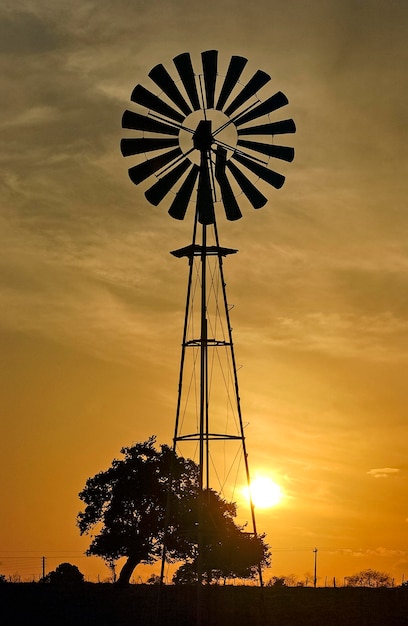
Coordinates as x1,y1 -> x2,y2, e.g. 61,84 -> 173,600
77,437 -> 198,585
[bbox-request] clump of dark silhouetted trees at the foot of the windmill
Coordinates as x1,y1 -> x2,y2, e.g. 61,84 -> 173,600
77,437 -> 268,584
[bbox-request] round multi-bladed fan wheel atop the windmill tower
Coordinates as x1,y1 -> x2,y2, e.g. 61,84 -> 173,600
121,50 -> 296,224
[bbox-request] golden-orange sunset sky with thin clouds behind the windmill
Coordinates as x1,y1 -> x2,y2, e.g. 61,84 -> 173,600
0,0 -> 408,584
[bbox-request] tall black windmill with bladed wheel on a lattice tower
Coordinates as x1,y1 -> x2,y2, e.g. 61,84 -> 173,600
121,50 -> 296,585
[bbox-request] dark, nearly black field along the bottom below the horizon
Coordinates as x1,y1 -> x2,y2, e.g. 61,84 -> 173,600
0,583 -> 408,626
